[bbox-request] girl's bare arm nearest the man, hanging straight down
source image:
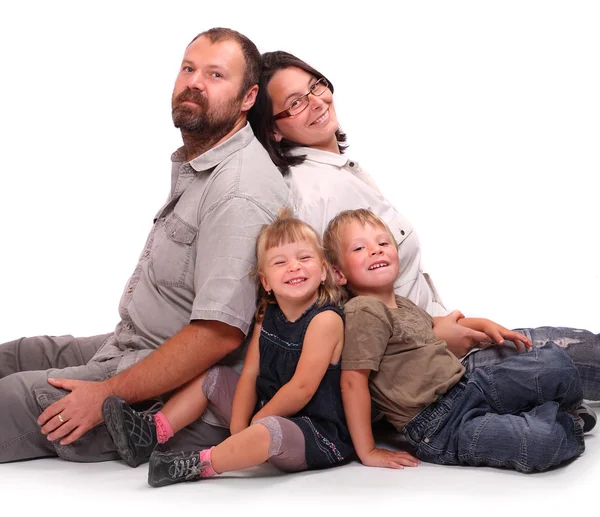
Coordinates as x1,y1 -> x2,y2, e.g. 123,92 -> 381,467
229,323 -> 262,434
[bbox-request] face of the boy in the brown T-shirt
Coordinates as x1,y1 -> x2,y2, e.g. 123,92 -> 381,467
336,221 -> 400,295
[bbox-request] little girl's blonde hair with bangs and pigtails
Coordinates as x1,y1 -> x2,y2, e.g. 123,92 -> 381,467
251,208 -> 344,321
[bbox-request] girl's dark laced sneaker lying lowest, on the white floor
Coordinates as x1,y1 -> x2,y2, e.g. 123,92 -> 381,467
148,451 -> 210,486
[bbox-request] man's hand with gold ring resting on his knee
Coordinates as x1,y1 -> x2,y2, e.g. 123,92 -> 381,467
38,379 -> 111,445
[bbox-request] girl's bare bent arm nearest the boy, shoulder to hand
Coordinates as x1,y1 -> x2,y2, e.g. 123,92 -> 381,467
252,311 -> 344,422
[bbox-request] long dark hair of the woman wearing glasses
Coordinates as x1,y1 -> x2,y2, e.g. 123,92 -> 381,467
248,50 -> 347,174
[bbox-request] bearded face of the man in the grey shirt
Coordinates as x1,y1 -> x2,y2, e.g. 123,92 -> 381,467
171,36 -> 246,135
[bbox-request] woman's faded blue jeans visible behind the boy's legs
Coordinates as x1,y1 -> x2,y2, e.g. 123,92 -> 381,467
463,327 -> 600,400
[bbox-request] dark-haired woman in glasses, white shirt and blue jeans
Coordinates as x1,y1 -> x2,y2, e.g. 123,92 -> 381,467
249,51 -> 600,400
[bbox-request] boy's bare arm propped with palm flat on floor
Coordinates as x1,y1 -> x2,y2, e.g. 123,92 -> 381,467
341,370 -> 419,469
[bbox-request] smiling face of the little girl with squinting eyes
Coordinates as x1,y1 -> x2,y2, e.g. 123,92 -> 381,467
260,240 -> 327,307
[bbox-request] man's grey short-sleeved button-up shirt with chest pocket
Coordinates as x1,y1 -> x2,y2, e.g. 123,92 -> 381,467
95,124 -> 288,371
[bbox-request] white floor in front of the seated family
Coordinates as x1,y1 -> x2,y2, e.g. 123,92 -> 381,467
0,418 -> 600,517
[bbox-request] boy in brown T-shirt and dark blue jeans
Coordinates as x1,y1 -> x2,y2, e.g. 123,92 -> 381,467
324,209 -> 595,472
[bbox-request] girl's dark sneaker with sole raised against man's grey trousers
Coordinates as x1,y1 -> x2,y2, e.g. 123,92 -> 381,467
102,397 -> 160,467
